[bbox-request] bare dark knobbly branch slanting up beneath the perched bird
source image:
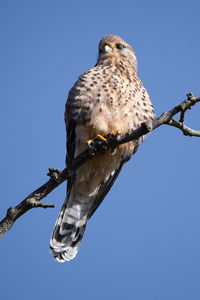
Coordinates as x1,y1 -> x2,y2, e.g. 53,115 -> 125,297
0,93 -> 200,238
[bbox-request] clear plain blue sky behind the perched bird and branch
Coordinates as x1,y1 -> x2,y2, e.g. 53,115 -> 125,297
0,0 -> 200,300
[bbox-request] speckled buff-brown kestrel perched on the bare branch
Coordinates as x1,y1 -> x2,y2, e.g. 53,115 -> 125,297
50,34 -> 154,262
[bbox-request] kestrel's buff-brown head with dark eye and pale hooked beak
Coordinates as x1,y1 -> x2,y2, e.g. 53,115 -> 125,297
98,34 -> 137,71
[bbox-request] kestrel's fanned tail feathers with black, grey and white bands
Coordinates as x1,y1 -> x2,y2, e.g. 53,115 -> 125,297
50,198 -> 89,262
